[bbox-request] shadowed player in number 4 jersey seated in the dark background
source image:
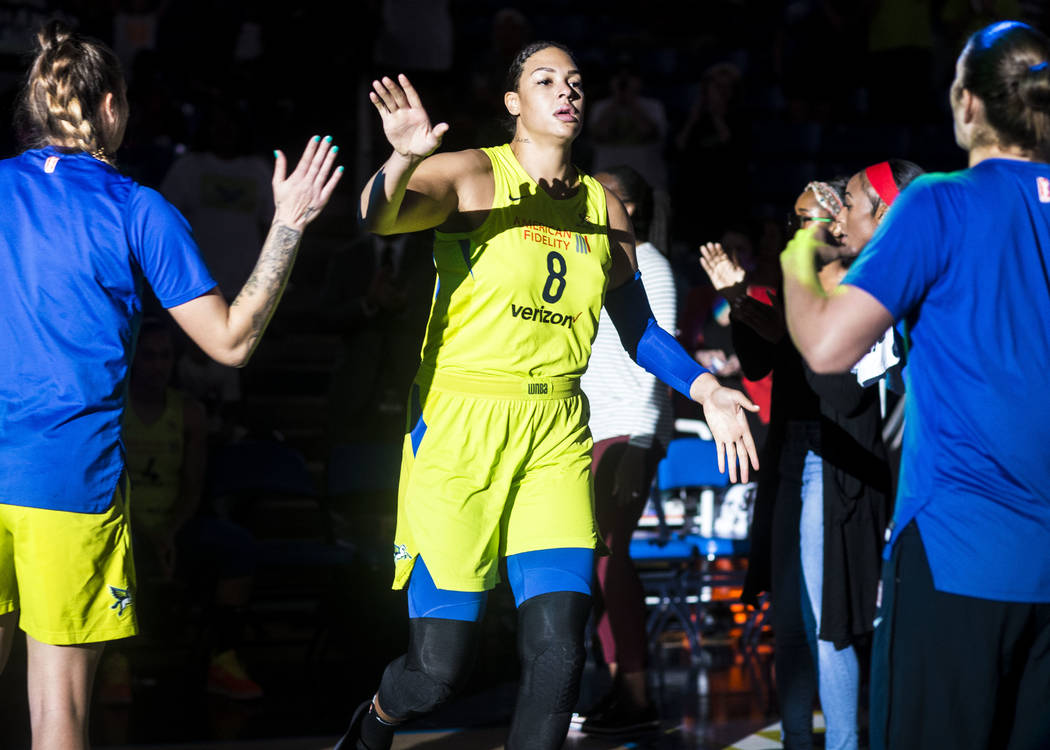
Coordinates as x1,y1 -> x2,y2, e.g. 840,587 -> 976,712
100,318 -> 263,703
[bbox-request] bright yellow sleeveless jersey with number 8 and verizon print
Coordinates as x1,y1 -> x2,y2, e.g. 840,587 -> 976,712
422,144 -> 611,377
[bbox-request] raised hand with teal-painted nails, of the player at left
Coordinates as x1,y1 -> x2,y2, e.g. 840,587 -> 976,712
273,136 -> 343,227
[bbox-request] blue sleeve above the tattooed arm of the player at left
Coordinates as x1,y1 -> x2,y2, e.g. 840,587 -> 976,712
127,186 -> 215,308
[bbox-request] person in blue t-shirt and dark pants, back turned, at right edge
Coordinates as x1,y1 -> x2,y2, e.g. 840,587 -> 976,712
781,22 -> 1050,750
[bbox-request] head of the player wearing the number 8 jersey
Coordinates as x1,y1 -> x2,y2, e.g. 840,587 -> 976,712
504,47 -> 584,140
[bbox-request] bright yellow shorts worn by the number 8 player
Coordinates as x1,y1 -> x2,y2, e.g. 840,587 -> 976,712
394,373 -> 597,591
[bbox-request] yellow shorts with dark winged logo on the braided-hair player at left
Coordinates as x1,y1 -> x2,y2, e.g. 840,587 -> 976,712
0,475 -> 139,645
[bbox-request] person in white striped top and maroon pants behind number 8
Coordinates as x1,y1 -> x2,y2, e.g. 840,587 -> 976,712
573,166 -> 677,734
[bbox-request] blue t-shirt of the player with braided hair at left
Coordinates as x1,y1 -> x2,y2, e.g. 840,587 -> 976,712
0,147 -> 215,513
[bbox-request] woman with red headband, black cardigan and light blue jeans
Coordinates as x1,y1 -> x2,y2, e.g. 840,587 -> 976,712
799,160 -> 922,750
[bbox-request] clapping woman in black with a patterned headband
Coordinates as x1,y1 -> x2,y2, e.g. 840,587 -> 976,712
700,178 -> 856,750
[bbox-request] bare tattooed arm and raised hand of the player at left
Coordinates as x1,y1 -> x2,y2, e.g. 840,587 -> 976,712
169,137 -> 342,368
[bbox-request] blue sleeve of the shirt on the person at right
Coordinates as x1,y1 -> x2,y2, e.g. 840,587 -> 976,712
842,174 -> 960,320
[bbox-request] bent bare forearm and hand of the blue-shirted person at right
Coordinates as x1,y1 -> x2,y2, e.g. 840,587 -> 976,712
780,223 -> 894,373
